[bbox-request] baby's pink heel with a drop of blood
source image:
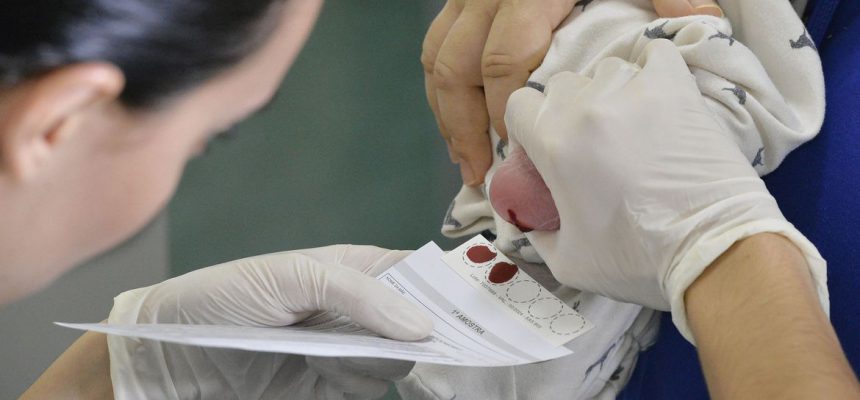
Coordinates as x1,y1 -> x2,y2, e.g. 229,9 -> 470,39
490,147 -> 559,232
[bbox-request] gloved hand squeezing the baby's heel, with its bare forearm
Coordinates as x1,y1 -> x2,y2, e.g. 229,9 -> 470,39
498,39 -> 860,399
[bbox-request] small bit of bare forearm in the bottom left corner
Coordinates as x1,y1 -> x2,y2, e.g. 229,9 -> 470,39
20,332 -> 113,400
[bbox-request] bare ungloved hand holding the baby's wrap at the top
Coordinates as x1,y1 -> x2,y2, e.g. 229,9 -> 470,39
421,0 -> 722,186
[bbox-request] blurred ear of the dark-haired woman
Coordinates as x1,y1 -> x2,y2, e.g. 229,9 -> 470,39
0,63 -> 125,180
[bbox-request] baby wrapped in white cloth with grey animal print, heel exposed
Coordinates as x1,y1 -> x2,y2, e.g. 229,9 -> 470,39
398,0 -> 824,399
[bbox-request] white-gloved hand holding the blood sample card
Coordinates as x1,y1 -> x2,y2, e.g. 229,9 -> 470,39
108,245 -> 432,399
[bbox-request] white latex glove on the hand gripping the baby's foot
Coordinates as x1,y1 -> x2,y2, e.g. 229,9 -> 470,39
500,40 -> 828,341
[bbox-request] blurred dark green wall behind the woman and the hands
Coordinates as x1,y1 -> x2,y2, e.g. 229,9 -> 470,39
169,0 -> 459,274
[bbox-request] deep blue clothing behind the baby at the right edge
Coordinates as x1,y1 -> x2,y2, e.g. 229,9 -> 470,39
619,0 -> 860,400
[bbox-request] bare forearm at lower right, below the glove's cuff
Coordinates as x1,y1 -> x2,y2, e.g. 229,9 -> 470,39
685,234 -> 860,399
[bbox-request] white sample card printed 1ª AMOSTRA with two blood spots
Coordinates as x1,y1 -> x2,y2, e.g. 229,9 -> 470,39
58,237 -> 591,367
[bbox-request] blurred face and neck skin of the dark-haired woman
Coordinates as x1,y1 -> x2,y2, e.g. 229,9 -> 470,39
0,0 -> 322,305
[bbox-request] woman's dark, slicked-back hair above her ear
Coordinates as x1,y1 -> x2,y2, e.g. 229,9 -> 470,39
0,0 -> 285,107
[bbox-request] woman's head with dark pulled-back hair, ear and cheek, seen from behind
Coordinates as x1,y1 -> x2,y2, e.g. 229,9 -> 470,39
0,0 -> 320,304
